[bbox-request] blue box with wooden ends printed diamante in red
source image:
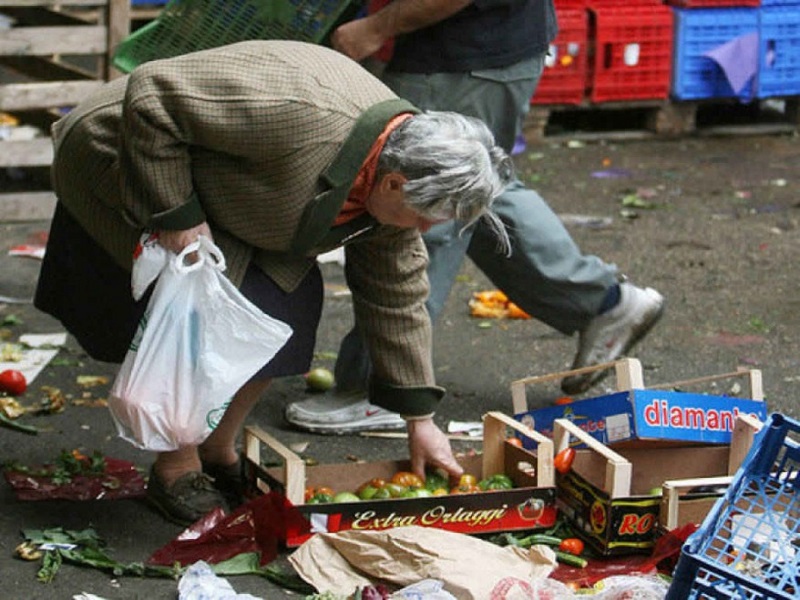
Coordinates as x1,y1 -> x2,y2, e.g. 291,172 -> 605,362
511,358 -> 767,447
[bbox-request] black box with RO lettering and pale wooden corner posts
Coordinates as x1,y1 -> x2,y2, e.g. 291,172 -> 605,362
553,419 -> 753,556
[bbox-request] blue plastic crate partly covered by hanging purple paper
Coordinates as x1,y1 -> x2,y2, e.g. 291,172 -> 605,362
671,8 -> 760,100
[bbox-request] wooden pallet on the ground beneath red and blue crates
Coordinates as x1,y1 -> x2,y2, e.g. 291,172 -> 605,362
524,96 -> 800,143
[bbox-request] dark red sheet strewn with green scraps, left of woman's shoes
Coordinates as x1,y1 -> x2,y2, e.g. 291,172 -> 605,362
3,449 -> 145,501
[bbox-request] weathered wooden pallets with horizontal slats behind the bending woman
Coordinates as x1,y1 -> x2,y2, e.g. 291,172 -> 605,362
0,0 -> 130,220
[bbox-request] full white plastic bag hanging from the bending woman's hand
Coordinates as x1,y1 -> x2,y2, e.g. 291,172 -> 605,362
108,236 -> 292,452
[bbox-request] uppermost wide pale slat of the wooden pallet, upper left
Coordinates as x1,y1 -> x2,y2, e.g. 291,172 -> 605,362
0,25 -> 108,56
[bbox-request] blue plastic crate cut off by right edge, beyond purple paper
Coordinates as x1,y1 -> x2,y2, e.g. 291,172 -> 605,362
756,5 -> 800,98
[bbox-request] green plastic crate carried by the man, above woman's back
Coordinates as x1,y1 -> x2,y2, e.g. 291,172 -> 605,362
113,0 -> 362,73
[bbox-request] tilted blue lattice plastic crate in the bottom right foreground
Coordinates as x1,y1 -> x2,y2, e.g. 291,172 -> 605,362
667,414 -> 800,600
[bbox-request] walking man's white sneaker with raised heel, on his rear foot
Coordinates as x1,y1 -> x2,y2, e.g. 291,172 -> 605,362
561,282 -> 664,395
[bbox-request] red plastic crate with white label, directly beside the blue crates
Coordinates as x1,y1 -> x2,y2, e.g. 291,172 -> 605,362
590,4 -> 674,102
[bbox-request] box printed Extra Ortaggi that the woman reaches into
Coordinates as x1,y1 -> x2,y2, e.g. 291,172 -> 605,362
245,413 -> 557,547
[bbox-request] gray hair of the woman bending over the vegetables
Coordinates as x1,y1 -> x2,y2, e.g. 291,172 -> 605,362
378,111 -> 514,254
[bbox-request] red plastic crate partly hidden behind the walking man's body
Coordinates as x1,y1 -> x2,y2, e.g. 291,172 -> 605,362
531,8 -> 589,104
